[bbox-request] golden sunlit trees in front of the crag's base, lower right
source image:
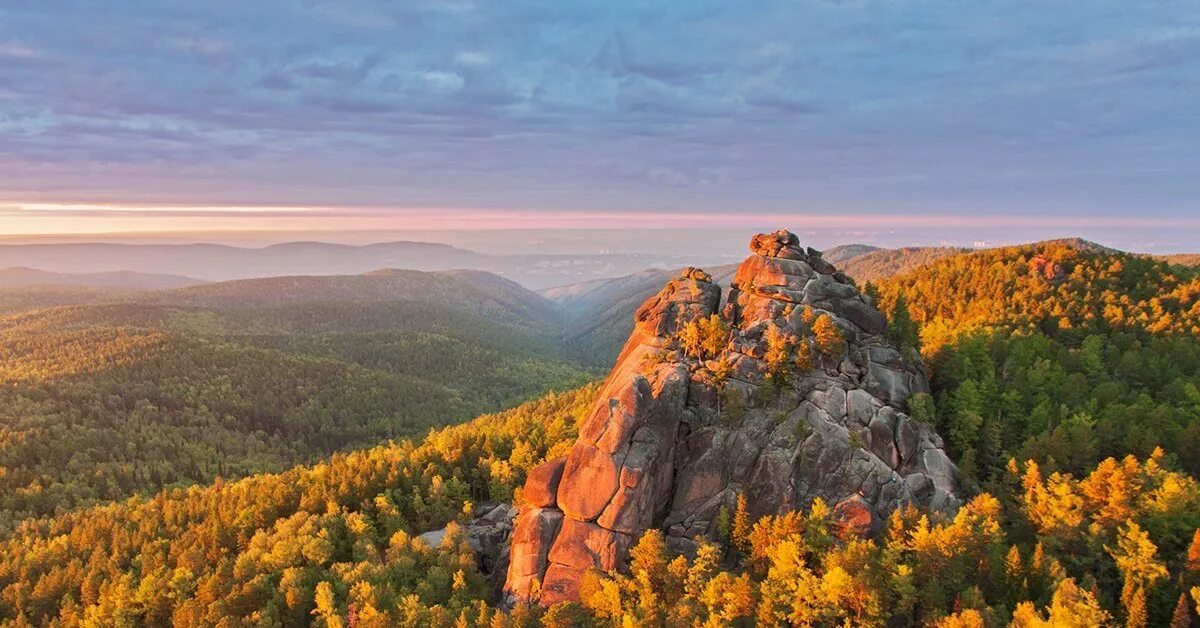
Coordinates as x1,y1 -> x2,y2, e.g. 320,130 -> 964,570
573,455 -> 1200,628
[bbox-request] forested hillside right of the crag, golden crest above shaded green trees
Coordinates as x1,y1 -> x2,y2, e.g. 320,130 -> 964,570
876,241 -> 1200,480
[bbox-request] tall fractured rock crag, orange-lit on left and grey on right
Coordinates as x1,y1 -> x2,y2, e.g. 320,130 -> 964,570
505,231 -> 960,604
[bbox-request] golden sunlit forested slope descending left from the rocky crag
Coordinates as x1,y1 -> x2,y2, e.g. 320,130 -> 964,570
0,387 -> 596,626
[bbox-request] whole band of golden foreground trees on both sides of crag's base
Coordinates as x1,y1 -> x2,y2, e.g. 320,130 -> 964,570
7,387 -> 1200,627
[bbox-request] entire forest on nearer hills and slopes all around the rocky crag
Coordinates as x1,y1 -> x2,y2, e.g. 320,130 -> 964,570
0,243 -> 1200,627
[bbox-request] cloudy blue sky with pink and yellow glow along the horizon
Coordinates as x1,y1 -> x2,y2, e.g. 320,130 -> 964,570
0,0 -> 1200,250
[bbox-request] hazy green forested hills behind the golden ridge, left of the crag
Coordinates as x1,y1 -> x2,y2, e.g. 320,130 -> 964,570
0,273 -> 595,528
